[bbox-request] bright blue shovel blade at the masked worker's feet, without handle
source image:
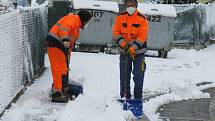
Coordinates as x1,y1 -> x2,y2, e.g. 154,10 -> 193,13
118,99 -> 143,119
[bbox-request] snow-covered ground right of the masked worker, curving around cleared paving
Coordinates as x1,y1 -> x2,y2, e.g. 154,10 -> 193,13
144,45 -> 215,119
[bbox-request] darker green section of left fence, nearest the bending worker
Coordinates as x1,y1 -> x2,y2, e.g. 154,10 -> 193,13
21,5 -> 48,81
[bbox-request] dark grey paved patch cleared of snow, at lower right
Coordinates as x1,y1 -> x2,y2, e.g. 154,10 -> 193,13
157,88 -> 215,121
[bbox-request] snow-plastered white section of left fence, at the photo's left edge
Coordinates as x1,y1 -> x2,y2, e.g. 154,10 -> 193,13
0,11 -> 24,115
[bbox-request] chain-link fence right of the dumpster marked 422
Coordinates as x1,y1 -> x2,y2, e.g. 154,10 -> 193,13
172,5 -> 215,48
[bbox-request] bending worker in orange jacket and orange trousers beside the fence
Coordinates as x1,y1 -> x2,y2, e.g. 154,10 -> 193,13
46,10 -> 91,102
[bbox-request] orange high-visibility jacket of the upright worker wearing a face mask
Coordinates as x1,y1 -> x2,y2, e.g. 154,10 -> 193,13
113,11 -> 148,54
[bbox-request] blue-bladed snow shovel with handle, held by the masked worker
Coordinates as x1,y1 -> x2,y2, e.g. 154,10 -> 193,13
118,53 -> 143,119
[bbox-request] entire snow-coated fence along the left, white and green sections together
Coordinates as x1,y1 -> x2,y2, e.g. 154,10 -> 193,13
0,4 -> 48,114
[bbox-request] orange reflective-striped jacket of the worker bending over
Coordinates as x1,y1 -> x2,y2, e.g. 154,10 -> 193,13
49,14 -> 81,43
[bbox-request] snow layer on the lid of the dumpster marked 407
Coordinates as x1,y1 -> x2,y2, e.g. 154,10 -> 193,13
72,0 -> 119,13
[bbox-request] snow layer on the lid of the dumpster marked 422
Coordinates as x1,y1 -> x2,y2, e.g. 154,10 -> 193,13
138,3 -> 177,17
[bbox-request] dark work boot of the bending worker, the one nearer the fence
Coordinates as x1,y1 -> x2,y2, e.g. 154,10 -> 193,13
51,92 -> 69,103
